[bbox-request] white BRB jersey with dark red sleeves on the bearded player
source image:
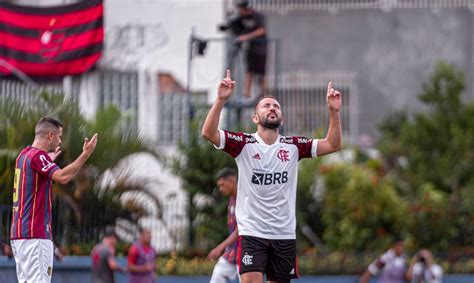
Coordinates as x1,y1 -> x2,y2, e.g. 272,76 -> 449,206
217,130 -> 318,239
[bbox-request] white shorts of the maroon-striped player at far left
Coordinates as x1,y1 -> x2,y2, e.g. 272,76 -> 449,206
11,239 -> 54,283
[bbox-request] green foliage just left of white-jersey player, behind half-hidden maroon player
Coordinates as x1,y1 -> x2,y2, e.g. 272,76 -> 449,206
168,119 -> 235,250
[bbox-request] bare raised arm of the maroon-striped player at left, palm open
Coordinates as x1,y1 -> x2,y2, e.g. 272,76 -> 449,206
52,134 -> 97,184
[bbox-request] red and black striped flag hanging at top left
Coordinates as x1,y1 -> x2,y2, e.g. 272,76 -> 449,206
0,0 -> 104,77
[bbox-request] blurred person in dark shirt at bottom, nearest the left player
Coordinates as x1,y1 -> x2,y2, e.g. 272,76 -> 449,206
91,230 -> 124,283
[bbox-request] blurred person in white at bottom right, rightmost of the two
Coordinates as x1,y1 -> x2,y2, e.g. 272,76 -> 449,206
406,249 -> 443,283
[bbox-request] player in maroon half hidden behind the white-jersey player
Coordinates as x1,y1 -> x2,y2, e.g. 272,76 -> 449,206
207,168 -> 238,283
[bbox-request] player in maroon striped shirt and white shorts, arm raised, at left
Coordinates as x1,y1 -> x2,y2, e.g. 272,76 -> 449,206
11,117 -> 97,283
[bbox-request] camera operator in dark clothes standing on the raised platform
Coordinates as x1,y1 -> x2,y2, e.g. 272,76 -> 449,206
237,0 -> 267,97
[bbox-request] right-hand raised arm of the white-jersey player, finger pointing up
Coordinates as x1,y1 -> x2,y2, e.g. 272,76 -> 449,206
317,81 -> 342,156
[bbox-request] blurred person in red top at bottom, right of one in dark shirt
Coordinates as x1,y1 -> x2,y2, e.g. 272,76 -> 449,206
127,228 -> 156,283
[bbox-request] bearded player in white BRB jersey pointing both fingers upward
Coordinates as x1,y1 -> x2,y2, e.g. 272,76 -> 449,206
202,71 -> 342,283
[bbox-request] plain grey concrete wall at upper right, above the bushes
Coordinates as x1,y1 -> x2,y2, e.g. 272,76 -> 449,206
267,9 -> 472,142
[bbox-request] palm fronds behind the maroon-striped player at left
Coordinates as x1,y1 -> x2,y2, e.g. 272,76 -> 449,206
0,93 -> 161,247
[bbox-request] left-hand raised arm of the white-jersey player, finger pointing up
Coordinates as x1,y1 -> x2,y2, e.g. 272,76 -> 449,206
201,70 -> 235,146
